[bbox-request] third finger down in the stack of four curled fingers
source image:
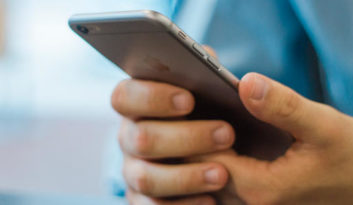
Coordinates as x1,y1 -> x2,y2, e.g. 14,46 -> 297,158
123,157 -> 228,197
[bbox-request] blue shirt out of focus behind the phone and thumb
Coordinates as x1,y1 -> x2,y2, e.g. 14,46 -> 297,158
105,0 -> 353,196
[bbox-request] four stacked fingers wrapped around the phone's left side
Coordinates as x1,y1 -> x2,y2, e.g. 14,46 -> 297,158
112,80 -> 235,205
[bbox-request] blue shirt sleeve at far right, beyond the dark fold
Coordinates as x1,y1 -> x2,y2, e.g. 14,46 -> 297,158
291,0 -> 353,115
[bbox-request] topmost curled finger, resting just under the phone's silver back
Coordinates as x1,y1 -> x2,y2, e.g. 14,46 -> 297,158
112,80 -> 195,117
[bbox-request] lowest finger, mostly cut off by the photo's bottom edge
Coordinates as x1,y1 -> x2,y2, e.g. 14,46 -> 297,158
127,189 -> 216,205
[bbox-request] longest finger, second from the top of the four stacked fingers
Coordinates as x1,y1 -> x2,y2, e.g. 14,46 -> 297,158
119,120 -> 235,159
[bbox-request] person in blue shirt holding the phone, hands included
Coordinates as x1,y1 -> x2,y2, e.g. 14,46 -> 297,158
112,0 -> 353,205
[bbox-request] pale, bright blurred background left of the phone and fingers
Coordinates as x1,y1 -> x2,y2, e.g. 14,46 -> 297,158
0,0 -> 142,196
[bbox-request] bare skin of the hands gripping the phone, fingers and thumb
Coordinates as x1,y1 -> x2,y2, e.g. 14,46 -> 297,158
112,50 -> 353,205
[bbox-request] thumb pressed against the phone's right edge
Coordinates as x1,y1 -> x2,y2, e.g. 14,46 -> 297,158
239,73 -> 342,144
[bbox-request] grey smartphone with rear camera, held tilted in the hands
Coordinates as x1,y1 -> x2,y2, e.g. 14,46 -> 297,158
69,10 -> 293,160
